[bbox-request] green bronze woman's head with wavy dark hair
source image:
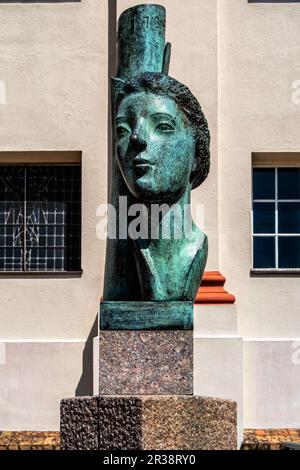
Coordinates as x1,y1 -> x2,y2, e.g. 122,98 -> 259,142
115,73 -> 210,203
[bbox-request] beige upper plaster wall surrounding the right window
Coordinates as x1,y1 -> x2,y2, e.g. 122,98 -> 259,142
218,0 -> 300,338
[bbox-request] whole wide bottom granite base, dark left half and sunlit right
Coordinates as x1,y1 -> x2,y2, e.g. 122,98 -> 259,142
61,396 -> 237,450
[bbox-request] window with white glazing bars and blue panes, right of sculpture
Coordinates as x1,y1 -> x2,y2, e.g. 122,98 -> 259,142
252,168 -> 300,270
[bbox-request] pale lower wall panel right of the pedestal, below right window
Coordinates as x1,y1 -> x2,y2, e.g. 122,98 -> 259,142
243,337 -> 300,429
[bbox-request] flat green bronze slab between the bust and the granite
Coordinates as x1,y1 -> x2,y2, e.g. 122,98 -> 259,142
100,302 -> 193,330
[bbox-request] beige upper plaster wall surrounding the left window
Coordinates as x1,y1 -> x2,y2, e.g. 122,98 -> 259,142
0,0 -> 108,340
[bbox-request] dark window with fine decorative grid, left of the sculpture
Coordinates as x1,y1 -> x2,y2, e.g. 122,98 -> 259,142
0,165 -> 81,272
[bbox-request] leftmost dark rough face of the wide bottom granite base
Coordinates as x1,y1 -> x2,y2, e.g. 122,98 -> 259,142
60,397 -> 99,450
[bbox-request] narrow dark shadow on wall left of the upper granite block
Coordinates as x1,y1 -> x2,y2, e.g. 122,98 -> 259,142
75,315 -> 98,397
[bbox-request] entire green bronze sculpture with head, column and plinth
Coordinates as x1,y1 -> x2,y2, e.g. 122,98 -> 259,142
101,5 -> 210,329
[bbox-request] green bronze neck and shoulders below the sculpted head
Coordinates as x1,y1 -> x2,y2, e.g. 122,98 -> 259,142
133,185 -> 207,301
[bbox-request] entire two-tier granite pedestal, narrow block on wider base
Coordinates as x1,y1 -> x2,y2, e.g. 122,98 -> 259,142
61,304 -> 237,450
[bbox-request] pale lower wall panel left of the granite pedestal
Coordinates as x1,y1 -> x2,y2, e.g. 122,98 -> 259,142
0,340 -> 86,431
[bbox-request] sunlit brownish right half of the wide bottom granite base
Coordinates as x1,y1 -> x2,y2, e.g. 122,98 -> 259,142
142,396 -> 237,450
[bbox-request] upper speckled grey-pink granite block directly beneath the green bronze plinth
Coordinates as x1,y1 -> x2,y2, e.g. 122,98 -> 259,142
99,330 -> 193,395
